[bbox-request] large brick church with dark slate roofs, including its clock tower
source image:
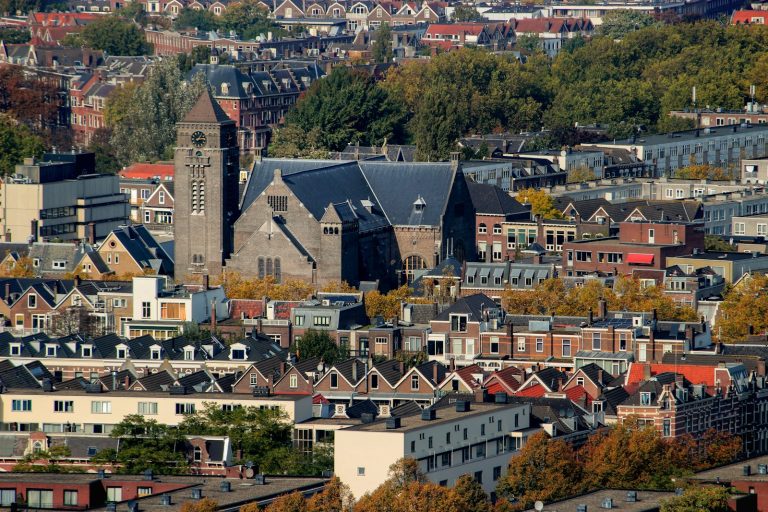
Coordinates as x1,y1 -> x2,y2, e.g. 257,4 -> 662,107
174,94 -> 475,289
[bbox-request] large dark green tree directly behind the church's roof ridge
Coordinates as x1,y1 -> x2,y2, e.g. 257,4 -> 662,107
282,67 -> 404,151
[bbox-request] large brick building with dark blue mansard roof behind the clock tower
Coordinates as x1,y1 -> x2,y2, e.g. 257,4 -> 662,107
190,64 -> 323,151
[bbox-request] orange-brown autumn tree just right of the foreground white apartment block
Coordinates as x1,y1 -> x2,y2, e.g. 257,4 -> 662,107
496,432 -> 583,508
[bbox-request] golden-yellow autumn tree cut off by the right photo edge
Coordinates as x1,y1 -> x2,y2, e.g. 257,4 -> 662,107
717,273 -> 768,342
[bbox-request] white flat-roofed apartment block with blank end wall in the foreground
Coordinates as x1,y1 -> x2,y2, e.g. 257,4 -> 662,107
334,401 -> 531,498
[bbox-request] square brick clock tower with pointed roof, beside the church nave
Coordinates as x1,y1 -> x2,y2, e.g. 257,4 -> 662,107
173,91 -> 240,282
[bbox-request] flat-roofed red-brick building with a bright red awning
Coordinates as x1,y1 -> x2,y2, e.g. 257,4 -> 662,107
562,221 -> 704,276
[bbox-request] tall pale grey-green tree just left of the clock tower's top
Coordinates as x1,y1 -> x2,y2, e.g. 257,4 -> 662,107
109,58 -> 207,165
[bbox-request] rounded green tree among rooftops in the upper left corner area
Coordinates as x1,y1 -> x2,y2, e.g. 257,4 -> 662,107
64,16 -> 151,55
